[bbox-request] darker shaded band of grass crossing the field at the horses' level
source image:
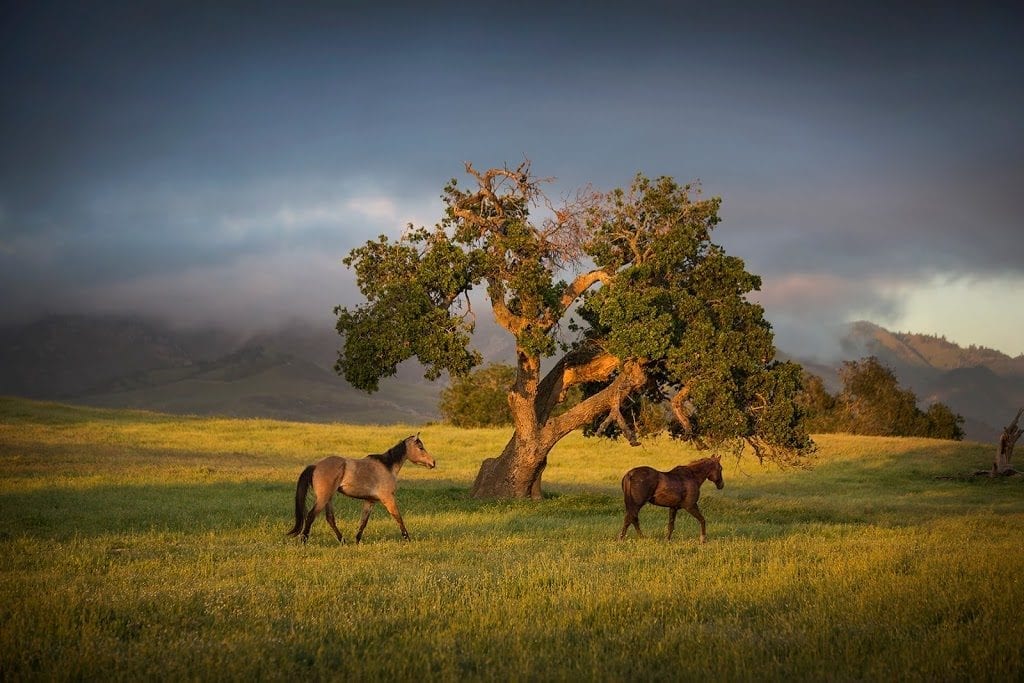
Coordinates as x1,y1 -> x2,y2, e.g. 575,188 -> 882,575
0,449 -> 1024,542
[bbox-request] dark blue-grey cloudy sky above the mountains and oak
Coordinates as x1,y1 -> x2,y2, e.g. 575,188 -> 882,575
0,0 -> 1024,355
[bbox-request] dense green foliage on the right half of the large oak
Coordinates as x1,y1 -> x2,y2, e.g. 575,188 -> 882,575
578,175 -> 812,457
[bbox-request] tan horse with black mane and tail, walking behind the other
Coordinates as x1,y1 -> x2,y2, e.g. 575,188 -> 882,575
288,434 -> 437,543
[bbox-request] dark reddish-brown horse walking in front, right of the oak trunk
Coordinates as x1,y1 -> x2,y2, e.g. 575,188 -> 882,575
618,456 -> 725,543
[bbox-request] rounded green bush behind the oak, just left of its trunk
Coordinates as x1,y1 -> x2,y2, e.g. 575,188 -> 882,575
440,364 -> 515,427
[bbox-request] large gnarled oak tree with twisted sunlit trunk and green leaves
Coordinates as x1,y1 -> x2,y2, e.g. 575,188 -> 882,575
336,163 -> 813,497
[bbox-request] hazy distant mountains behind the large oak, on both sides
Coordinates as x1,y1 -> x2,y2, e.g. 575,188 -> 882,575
0,315 -> 1024,440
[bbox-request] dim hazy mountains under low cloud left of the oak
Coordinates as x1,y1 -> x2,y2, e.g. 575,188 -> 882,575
0,315 -> 441,424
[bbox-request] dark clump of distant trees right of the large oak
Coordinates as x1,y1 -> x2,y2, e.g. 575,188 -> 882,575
797,356 -> 964,441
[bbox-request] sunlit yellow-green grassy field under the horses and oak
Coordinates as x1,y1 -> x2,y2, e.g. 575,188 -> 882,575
0,398 -> 1024,681
